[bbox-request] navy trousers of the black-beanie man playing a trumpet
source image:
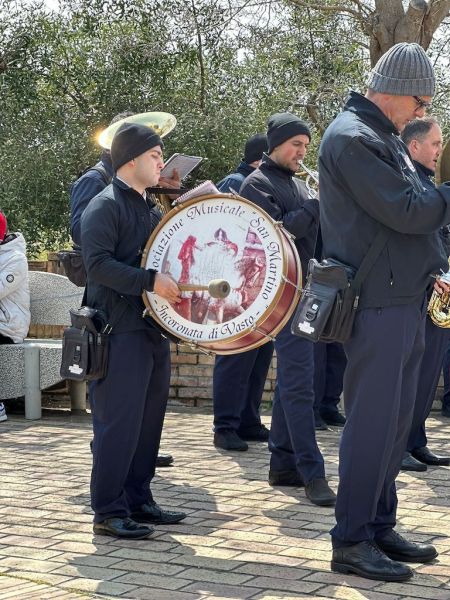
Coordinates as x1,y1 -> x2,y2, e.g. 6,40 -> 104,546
269,317 -> 325,483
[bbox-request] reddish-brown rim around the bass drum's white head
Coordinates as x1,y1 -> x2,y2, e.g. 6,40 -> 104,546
141,194 -> 302,346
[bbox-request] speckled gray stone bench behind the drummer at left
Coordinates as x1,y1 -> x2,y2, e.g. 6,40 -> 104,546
0,271 -> 86,419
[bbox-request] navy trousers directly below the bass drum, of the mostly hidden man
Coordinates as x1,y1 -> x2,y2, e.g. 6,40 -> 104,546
213,342 -> 273,431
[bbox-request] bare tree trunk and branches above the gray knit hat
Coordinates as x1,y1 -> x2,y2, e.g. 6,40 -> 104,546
288,0 -> 450,66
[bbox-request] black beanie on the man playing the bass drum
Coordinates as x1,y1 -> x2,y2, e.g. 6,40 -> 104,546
111,123 -> 164,172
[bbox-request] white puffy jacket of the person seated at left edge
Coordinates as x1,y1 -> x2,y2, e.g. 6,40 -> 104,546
0,233 -> 31,343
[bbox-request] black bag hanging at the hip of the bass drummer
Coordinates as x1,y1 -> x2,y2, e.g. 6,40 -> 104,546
60,306 -> 109,381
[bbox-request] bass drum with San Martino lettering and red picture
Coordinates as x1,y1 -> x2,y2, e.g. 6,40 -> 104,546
141,194 -> 302,354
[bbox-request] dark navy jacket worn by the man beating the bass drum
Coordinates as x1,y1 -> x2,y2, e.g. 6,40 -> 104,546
81,177 -> 161,333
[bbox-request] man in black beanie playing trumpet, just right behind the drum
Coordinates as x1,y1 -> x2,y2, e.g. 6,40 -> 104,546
240,113 -> 335,506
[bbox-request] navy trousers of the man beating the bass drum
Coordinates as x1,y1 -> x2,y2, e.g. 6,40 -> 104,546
89,330 -> 170,523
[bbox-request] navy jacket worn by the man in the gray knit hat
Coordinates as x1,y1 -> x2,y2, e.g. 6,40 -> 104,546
319,92 -> 450,308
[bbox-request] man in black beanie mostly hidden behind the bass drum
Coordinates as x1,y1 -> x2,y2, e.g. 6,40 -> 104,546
213,133 -> 273,451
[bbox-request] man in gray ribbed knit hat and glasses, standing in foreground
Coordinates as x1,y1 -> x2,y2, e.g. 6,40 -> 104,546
319,43 -> 450,581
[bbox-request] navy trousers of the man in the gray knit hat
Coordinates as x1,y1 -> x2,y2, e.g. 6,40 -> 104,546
331,296 -> 426,547
